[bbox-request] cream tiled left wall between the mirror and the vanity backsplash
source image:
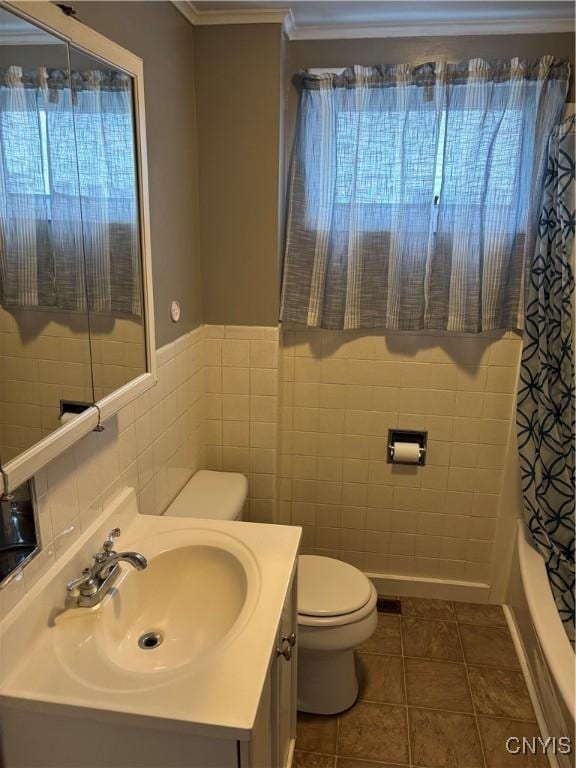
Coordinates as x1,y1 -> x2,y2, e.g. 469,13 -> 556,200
0,329 -> 204,615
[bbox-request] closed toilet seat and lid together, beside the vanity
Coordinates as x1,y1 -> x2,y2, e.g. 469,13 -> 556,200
298,555 -> 377,627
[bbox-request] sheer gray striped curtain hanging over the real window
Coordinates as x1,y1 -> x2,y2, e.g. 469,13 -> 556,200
281,56 -> 569,333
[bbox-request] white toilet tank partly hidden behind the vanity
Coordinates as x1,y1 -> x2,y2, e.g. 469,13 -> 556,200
164,469 -> 248,520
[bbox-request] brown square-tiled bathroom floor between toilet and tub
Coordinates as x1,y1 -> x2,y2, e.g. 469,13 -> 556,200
294,598 -> 549,768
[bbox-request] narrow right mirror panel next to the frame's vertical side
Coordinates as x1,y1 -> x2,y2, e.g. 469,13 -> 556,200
69,47 -> 146,400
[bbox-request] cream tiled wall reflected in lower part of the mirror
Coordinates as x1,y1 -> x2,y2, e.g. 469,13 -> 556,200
0,307 -> 146,462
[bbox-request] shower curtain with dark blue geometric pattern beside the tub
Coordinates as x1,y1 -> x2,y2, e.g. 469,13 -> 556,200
517,116 -> 576,641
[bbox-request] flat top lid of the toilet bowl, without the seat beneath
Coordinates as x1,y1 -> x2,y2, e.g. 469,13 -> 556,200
298,555 -> 372,616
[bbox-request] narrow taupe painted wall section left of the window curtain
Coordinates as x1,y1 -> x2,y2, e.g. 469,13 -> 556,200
194,24 -> 283,325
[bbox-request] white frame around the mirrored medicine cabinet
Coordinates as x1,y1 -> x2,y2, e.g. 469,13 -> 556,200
0,0 -> 157,493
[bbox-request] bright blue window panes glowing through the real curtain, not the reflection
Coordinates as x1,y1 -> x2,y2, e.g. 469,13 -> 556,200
336,110 -> 522,212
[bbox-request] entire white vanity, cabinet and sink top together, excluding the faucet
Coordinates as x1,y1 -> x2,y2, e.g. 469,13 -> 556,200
0,496 -> 301,768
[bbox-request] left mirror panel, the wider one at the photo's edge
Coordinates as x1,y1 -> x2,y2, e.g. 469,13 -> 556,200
0,8 -> 94,465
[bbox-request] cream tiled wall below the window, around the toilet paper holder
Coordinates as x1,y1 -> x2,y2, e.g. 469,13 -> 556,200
278,330 -> 520,583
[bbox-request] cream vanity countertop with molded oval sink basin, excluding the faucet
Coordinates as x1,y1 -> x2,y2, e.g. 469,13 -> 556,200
0,488 -> 300,736
